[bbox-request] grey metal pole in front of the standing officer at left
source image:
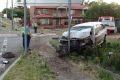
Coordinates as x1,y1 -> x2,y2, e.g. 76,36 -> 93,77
24,0 -> 27,54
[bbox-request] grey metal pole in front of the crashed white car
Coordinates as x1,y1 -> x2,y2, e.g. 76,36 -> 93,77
68,0 -> 71,53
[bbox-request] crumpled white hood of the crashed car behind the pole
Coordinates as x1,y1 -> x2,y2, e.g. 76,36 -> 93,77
62,28 -> 91,39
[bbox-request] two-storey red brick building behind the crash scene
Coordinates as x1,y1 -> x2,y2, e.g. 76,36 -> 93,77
30,4 -> 88,28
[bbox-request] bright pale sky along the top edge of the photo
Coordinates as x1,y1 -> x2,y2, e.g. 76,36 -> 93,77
0,0 -> 120,12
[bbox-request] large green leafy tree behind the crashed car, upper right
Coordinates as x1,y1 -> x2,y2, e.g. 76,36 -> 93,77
85,2 -> 120,21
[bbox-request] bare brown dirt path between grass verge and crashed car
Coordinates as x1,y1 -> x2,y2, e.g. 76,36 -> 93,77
39,44 -> 93,80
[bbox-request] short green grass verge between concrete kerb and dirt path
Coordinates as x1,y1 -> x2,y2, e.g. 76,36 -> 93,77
4,52 -> 55,80
